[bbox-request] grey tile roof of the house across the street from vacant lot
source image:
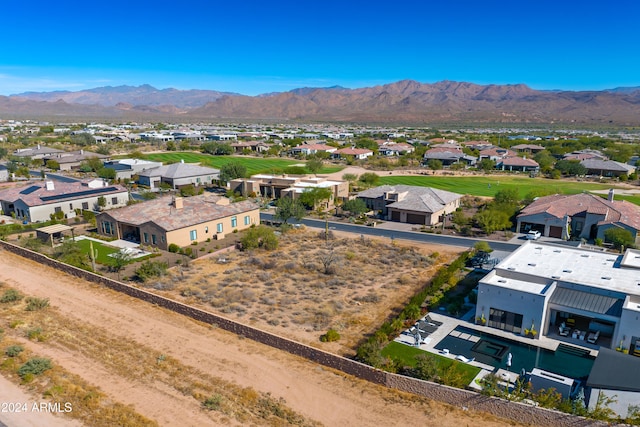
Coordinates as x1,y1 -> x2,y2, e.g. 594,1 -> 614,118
358,185 -> 462,213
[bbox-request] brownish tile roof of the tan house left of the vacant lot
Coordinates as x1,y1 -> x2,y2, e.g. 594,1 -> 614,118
102,194 -> 260,231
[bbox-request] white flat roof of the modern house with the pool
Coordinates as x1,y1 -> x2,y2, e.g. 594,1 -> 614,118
492,241 -> 640,295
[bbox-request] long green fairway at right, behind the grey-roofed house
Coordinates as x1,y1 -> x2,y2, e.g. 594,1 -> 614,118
380,175 -> 640,204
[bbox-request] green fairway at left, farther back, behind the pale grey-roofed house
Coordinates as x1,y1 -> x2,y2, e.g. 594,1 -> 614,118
129,151 -> 344,175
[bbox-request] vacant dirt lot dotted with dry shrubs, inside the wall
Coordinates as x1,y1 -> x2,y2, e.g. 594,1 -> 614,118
145,229 -> 461,355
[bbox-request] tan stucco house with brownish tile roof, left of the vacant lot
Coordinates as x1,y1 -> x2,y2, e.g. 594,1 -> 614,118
96,194 -> 260,250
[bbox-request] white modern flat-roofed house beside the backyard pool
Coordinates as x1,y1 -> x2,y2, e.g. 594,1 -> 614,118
476,241 -> 640,357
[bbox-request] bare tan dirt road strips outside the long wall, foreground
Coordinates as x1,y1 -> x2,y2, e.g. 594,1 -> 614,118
0,251 -> 514,427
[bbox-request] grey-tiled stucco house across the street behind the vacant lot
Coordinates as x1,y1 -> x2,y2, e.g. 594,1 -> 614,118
358,185 -> 462,225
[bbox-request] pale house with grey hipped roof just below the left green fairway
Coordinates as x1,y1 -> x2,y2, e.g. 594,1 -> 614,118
138,162 -> 220,190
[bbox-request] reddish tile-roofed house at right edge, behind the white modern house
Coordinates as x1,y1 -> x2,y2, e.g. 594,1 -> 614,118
517,190 -> 640,245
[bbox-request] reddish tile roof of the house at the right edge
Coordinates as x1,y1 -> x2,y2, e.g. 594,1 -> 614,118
518,193 -> 640,230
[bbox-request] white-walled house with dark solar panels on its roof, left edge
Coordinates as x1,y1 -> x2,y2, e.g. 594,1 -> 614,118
0,179 -> 129,222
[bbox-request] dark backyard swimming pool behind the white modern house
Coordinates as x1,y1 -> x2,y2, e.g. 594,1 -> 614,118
434,326 -> 595,379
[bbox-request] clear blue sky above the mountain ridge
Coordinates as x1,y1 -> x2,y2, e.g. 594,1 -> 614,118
0,0 -> 640,95
